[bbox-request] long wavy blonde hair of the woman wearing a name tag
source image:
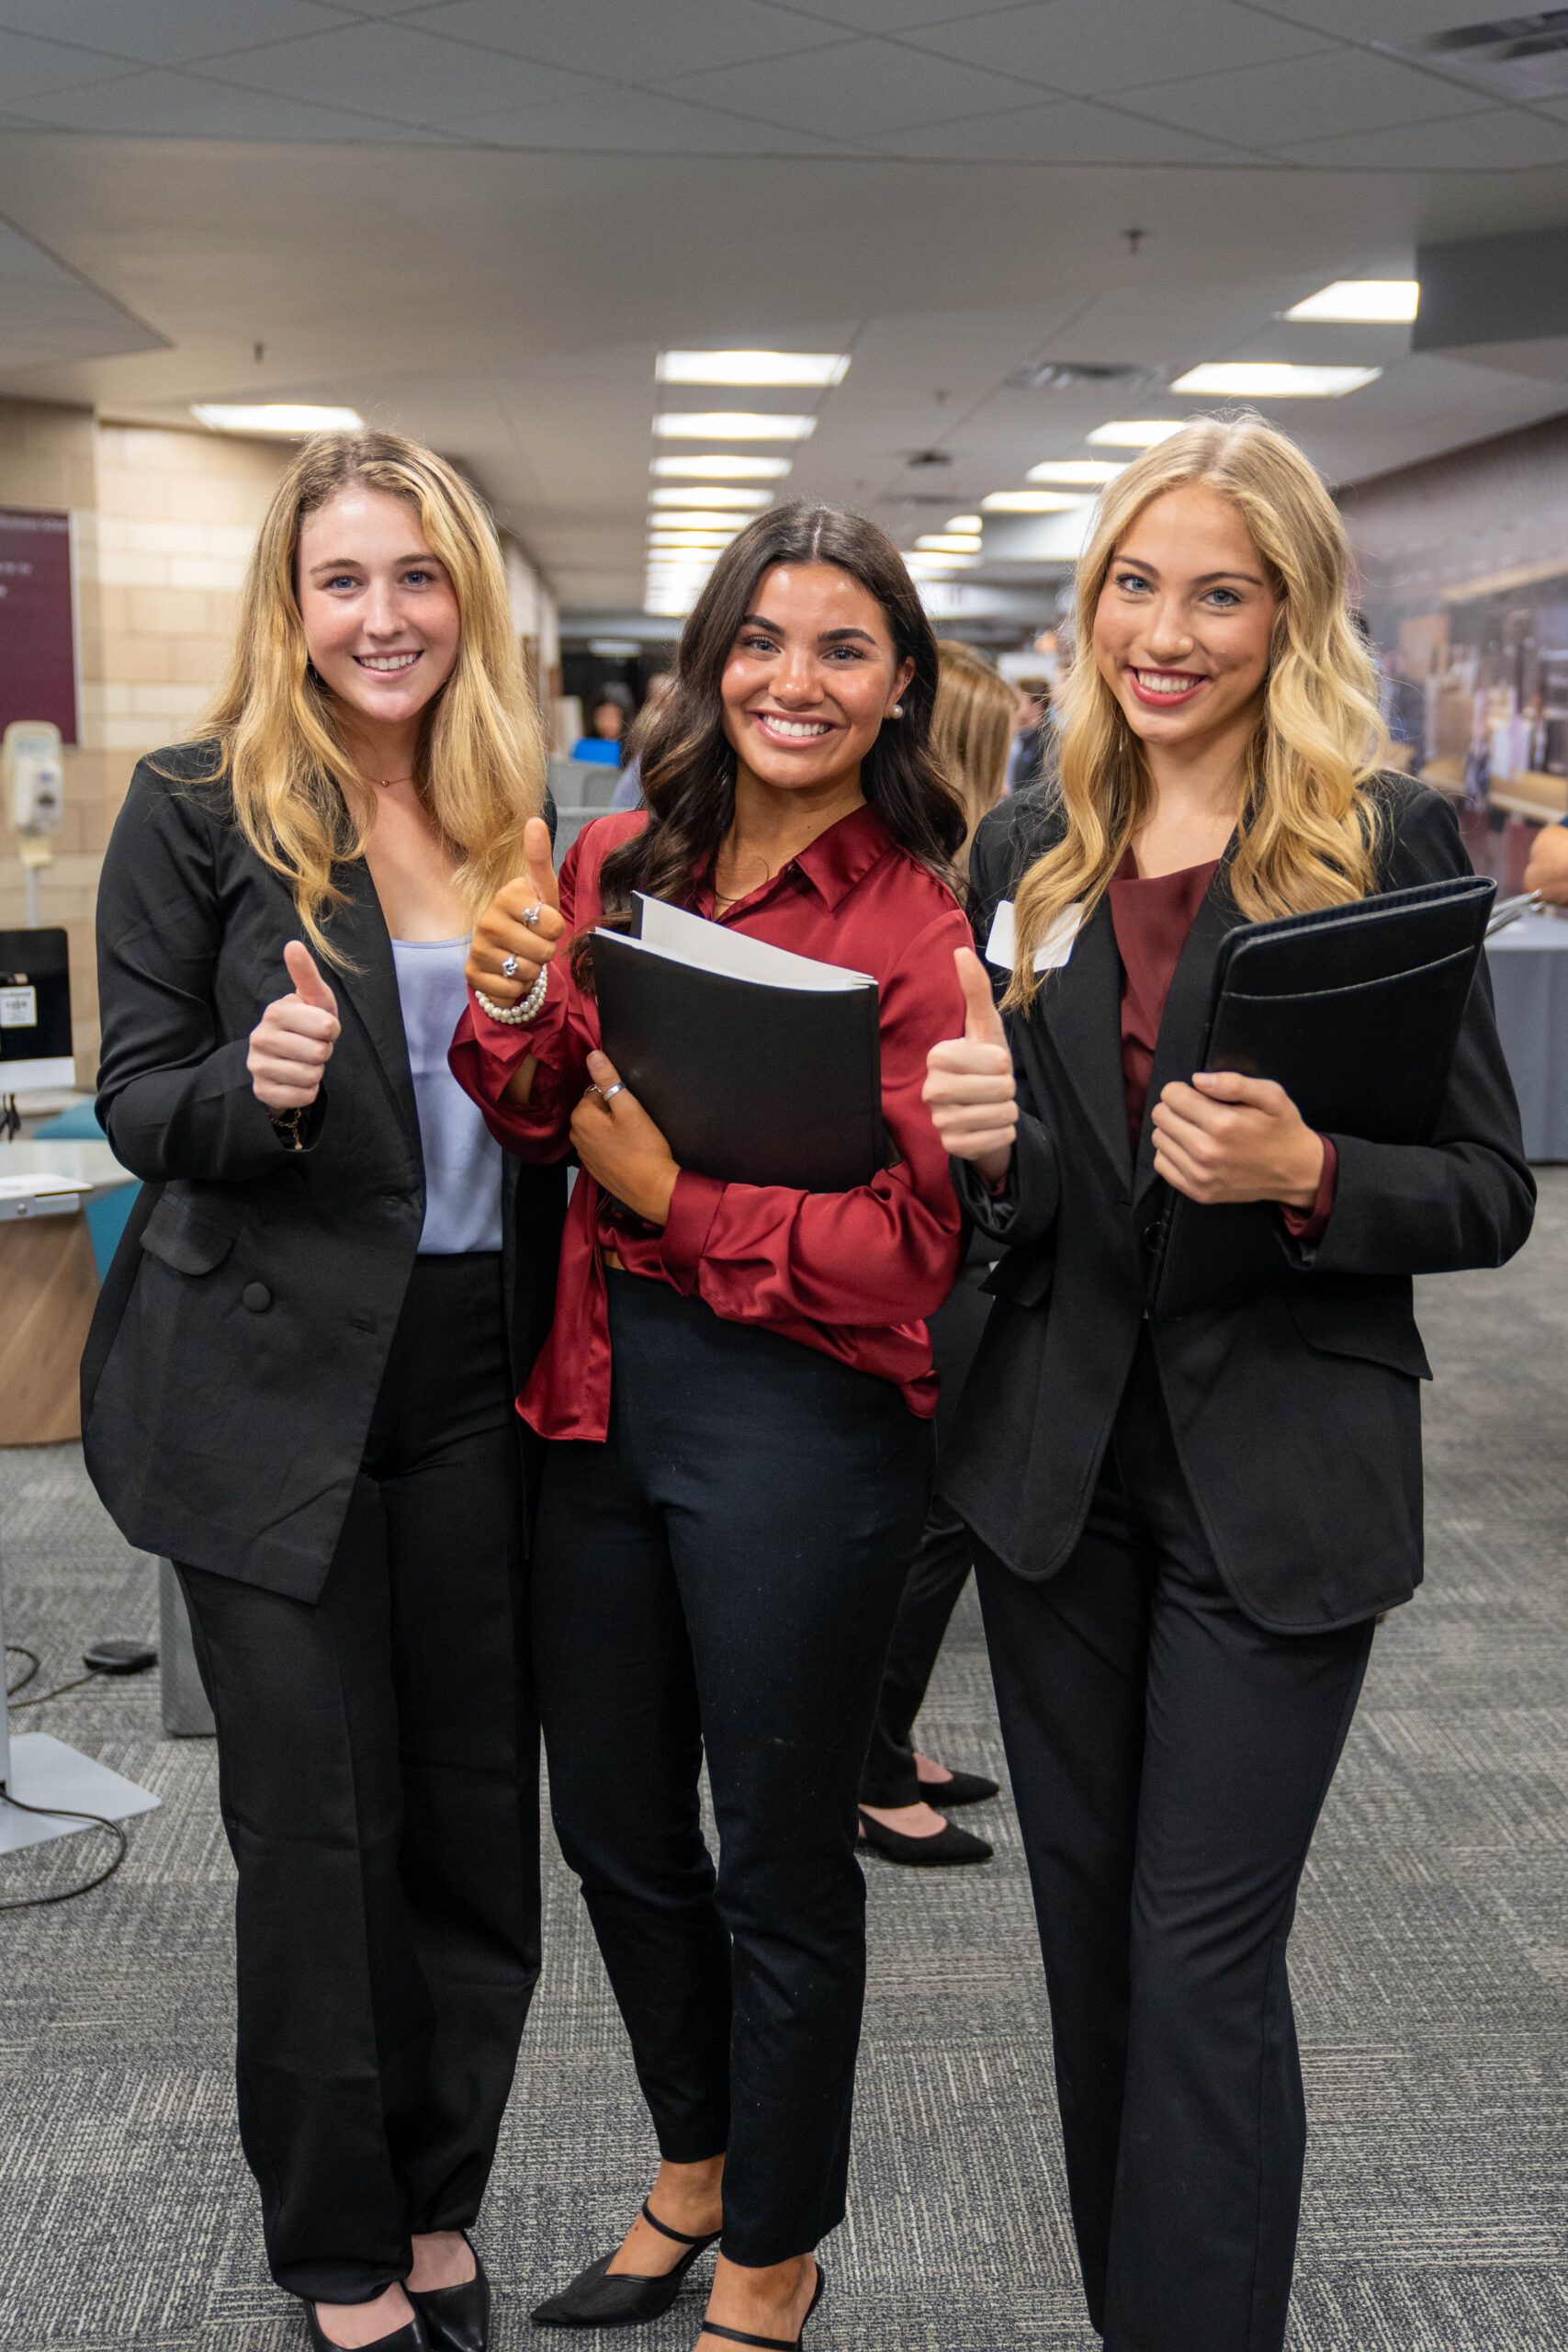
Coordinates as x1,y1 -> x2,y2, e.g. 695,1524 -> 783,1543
1006,414 -> 1387,1009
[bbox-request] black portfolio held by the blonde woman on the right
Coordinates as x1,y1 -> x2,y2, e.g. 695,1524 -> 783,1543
1149,875 -> 1497,1315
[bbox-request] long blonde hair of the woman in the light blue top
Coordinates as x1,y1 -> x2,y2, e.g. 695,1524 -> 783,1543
202,433 -> 546,965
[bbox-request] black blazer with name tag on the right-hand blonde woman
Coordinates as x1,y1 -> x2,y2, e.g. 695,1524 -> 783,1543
942,776 -> 1535,1633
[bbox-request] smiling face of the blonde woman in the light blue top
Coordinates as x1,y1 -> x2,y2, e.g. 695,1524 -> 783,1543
294,487 -> 461,746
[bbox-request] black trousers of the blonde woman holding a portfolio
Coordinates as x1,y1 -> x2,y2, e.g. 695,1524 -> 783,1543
976,1343 -> 1373,2352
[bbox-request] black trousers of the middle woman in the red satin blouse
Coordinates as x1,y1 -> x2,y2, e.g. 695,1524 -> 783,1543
534,1272 -> 931,2265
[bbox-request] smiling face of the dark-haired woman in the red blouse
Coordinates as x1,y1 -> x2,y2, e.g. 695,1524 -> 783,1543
719,564 -> 915,790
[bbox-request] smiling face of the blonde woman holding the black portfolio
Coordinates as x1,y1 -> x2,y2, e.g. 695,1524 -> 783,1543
1093,482 -> 1279,751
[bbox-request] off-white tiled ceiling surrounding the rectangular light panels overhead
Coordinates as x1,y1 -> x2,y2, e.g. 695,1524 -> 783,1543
0,0 -> 1568,614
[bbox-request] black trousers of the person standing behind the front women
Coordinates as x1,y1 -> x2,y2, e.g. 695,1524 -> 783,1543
861,1256 -> 989,1806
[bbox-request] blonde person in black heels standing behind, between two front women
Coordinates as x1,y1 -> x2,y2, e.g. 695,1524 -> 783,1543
861,638 -> 1016,1868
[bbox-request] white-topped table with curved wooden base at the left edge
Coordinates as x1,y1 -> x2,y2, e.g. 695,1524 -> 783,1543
0,1138 -> 136,1446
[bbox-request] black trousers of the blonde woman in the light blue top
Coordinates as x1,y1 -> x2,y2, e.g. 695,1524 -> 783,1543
181,1253 -> 538,2302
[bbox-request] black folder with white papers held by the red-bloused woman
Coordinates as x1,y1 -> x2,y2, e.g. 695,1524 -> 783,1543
592,899 -> 888,1193
